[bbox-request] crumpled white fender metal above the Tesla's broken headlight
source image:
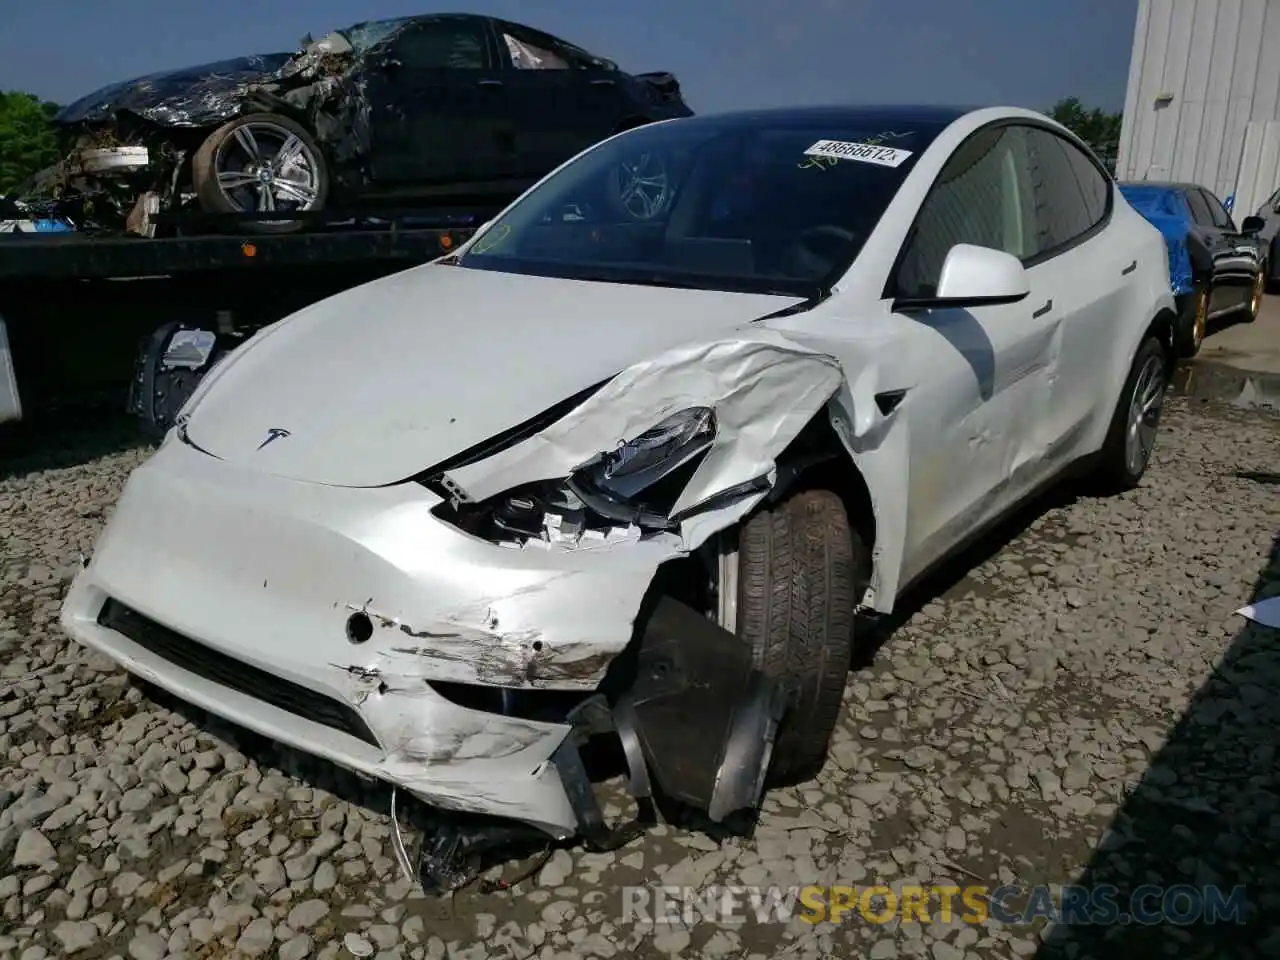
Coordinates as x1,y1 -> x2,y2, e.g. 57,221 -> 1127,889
445,328 -> 844,550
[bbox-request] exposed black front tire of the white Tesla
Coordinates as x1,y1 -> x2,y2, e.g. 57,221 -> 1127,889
737,489 -> 867,785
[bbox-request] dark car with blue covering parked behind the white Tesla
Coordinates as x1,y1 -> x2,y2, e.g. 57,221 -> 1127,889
1119,180 -> 1267,357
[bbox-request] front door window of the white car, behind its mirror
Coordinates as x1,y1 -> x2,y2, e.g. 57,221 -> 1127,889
895,125 -> 1038,297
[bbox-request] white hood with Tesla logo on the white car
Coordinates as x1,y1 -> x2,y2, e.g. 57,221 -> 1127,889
187,264 -> 801,486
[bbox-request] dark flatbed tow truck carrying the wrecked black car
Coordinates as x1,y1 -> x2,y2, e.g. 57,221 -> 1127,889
0,209 -> 486,435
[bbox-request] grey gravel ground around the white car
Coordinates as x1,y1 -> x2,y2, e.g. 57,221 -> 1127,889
0,391 -> 1280,960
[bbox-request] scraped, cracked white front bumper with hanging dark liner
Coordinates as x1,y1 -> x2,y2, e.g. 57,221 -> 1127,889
61,436 -> 782,844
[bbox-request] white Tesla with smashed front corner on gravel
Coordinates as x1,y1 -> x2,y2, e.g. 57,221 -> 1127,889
61,108 -> 1175,885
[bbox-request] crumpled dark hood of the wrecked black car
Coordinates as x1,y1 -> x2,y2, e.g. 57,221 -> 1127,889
54,54 -> 296,127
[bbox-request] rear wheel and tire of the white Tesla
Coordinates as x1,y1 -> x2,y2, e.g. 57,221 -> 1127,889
1096,337 -> 1169,493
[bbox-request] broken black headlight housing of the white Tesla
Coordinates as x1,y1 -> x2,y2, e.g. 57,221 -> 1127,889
436,407 -> 717,543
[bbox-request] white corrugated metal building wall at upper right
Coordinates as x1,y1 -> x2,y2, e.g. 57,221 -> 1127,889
1116,0 -> 1280,198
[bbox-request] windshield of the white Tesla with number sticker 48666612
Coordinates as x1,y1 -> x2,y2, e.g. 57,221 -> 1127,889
458,116 -> 941,297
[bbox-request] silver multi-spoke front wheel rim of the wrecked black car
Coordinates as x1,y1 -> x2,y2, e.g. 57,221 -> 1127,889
214,120 -> 320,212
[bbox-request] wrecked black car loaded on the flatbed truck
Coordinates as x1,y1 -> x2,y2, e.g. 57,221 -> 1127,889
32,14 -> 692,237
